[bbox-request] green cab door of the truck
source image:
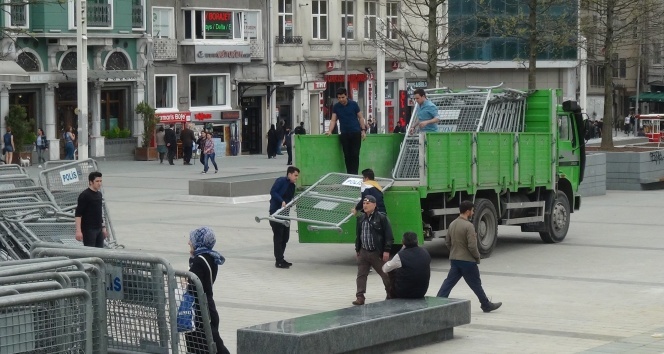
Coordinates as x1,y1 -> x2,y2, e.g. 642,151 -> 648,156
558,114 -> 583,190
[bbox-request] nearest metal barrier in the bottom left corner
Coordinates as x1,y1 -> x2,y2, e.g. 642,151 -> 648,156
0,289 -> 93,354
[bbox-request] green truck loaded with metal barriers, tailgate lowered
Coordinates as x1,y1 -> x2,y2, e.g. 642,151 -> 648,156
273,88 -> 585,257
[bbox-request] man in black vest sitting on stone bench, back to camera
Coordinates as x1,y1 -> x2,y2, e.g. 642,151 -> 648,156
383,232 -> 431,299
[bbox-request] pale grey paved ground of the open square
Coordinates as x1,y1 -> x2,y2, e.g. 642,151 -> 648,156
19,156 -> 664,354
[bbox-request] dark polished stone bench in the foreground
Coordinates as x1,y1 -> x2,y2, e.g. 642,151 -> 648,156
237,297 -> 470,354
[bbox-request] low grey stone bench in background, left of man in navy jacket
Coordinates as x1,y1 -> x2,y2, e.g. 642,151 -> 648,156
189,171 -> 286,198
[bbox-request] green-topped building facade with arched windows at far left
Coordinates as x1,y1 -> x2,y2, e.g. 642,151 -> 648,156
0,0 -> 146,160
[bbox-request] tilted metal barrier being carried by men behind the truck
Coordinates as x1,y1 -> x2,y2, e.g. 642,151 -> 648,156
255,173 -> 394,232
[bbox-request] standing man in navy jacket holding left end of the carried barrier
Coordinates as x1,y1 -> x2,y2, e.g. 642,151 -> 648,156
270,166 -> 300,269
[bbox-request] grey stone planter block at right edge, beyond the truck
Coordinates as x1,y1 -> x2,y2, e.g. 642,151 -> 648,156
605,150 -> 664,190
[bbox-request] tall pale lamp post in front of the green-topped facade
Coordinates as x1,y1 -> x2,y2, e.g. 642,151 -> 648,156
76,0 -> 88,160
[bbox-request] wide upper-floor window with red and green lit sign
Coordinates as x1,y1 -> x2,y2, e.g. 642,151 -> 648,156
184,10 -> 249,39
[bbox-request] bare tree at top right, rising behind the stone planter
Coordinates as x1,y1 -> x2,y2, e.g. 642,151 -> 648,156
581,0 -> 663,149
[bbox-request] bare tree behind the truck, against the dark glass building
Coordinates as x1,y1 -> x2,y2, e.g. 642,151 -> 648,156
477,0 -> 578,90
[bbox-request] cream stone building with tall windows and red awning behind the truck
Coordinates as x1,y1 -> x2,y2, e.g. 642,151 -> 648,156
270,0 -> 427,134
